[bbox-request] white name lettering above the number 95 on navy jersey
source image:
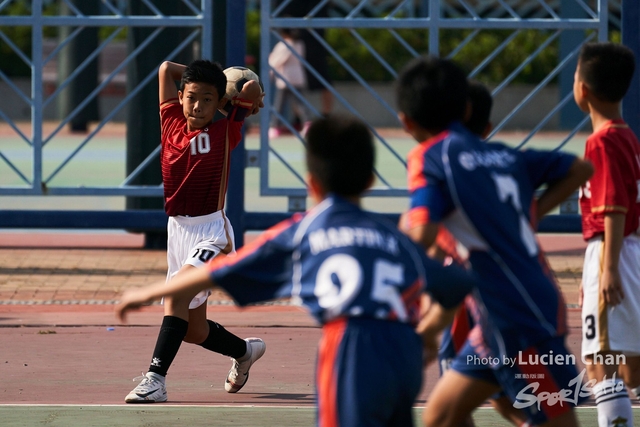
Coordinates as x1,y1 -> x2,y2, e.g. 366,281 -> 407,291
309,227 -> 399,255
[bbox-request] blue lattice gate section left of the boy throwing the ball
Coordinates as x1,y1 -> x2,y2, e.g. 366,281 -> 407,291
0,0 -> 213,197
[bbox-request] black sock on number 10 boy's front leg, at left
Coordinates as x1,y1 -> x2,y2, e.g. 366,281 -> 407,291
149,316 -> 189,377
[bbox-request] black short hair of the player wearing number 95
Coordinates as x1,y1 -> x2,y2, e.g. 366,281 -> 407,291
306,115 -> 375,197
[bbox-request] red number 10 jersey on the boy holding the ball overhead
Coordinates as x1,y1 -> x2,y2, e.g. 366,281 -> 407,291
160,103 -> 244,216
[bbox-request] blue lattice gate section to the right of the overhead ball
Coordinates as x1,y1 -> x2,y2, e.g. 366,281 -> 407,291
228,0 -> 616,244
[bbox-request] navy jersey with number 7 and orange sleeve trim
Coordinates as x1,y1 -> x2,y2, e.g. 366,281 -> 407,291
409,124 -> 575,352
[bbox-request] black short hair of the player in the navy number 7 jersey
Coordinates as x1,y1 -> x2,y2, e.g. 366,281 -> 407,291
396,56 -> 468,131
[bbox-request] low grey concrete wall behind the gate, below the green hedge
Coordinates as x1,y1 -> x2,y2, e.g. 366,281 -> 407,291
0,79 -> 559,130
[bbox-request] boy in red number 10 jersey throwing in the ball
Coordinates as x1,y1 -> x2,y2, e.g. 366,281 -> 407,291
125,60 -> 266,403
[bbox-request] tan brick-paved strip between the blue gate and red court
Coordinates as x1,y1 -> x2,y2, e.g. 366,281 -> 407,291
0,231 -> 585,311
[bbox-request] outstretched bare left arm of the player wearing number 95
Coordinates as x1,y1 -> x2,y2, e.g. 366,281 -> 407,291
115,268 -> 214,322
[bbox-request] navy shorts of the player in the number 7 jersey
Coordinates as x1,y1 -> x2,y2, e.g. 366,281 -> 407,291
451,337 -> 591,425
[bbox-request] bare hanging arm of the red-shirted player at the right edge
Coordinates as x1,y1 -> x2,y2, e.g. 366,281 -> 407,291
600,212 -> 625,305
